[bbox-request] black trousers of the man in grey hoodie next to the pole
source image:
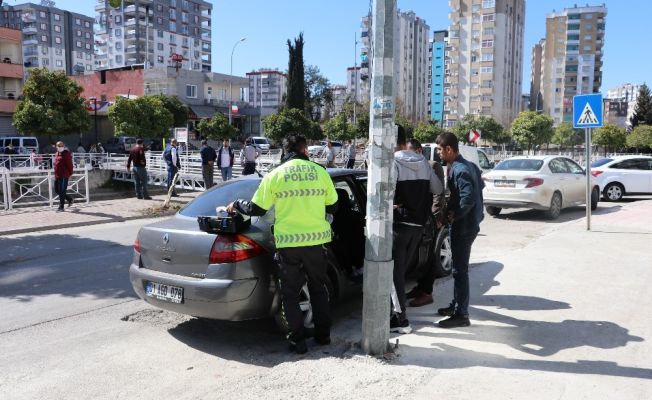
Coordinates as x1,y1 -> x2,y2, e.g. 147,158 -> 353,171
393,223 -> 423,319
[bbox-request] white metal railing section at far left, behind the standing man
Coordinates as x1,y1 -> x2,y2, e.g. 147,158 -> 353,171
0,169 -> 90,210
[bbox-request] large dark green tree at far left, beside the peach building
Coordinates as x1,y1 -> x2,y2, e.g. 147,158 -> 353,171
13,68 -> 91,137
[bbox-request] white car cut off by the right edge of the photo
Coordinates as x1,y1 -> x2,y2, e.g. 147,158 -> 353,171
591,156 -> 652,201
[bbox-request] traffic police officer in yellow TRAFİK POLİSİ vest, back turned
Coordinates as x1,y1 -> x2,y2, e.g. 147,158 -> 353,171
227,135 -> 337,354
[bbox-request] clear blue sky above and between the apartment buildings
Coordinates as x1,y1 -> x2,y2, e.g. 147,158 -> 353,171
44,0 -> 652,92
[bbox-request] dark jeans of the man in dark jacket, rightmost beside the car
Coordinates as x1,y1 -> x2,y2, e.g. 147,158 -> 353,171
451,231 -> 478,317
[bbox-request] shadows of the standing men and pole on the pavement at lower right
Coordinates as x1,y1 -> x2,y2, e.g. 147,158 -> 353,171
401,262 -> 652,379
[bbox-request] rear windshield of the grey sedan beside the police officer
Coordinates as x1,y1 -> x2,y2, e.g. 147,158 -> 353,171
179,178 -> 260,217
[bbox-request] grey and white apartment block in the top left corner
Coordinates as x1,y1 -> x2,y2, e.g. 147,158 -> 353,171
0,3 -> 94,75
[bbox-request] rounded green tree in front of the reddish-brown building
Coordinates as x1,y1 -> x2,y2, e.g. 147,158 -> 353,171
109,96 -> 174,139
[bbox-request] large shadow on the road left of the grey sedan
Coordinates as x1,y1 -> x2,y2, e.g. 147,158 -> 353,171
0,234 -> 136,302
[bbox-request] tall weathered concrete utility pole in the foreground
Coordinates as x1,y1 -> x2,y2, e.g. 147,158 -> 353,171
362,0 -> 396,355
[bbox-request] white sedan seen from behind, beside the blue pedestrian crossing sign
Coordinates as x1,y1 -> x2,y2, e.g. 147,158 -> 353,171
482,156 -> 600,219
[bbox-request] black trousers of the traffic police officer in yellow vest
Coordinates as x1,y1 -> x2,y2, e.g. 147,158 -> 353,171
278,245 -> 331,342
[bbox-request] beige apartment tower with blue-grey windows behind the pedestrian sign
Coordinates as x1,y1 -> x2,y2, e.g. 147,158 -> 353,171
541,6 -> 607,124
